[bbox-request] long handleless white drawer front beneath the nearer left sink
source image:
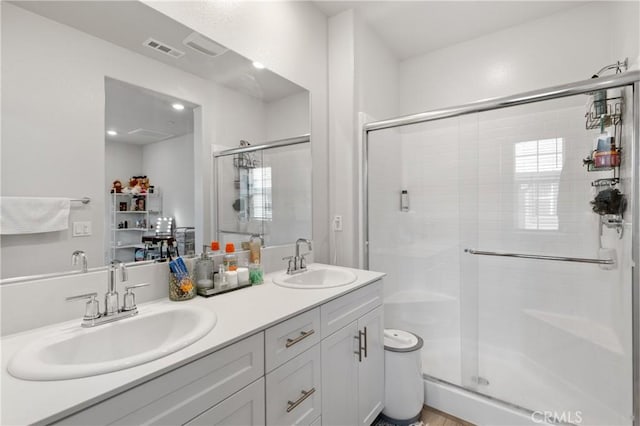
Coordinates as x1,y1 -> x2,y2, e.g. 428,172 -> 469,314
59,333 -> 264,425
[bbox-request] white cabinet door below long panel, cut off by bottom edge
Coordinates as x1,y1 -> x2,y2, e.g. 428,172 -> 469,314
186,378 -> 265,426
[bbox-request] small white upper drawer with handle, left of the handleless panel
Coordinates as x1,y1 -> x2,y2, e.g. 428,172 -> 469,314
265,308 -> 320,371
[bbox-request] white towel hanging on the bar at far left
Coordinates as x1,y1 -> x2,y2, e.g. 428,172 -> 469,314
0,197 -> 71,235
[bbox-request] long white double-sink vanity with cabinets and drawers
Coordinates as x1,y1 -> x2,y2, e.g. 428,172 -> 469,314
0,264 -> 384,425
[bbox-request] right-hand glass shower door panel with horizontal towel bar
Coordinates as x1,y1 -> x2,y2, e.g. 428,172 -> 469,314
472,90 -> 632,425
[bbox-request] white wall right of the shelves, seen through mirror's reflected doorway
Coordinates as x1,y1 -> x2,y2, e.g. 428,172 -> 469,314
142,133 -> 196,231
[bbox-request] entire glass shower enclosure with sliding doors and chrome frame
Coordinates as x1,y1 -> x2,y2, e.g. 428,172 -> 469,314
363,71 -> 640,425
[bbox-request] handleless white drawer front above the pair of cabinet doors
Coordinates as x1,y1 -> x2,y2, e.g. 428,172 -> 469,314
320,280 -> 382,338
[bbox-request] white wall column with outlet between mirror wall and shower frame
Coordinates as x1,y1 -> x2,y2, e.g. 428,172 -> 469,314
329,10 -> 398,266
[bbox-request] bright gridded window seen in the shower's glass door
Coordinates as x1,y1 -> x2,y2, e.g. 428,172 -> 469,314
514,138 -> 563,231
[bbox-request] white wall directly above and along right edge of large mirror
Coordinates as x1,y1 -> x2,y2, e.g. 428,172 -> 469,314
145,1 -> 329,262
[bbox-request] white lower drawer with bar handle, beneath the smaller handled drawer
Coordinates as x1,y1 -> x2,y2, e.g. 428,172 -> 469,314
267,345 -> 322,426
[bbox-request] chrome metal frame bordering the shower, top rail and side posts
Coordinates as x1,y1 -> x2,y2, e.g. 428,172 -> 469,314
361,70 -> 640,426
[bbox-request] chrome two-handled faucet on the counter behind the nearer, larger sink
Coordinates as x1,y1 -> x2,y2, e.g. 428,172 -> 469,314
67,260 -> 149,327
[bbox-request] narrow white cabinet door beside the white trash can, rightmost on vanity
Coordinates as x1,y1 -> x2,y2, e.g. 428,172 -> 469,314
358,306 -> 384,426
